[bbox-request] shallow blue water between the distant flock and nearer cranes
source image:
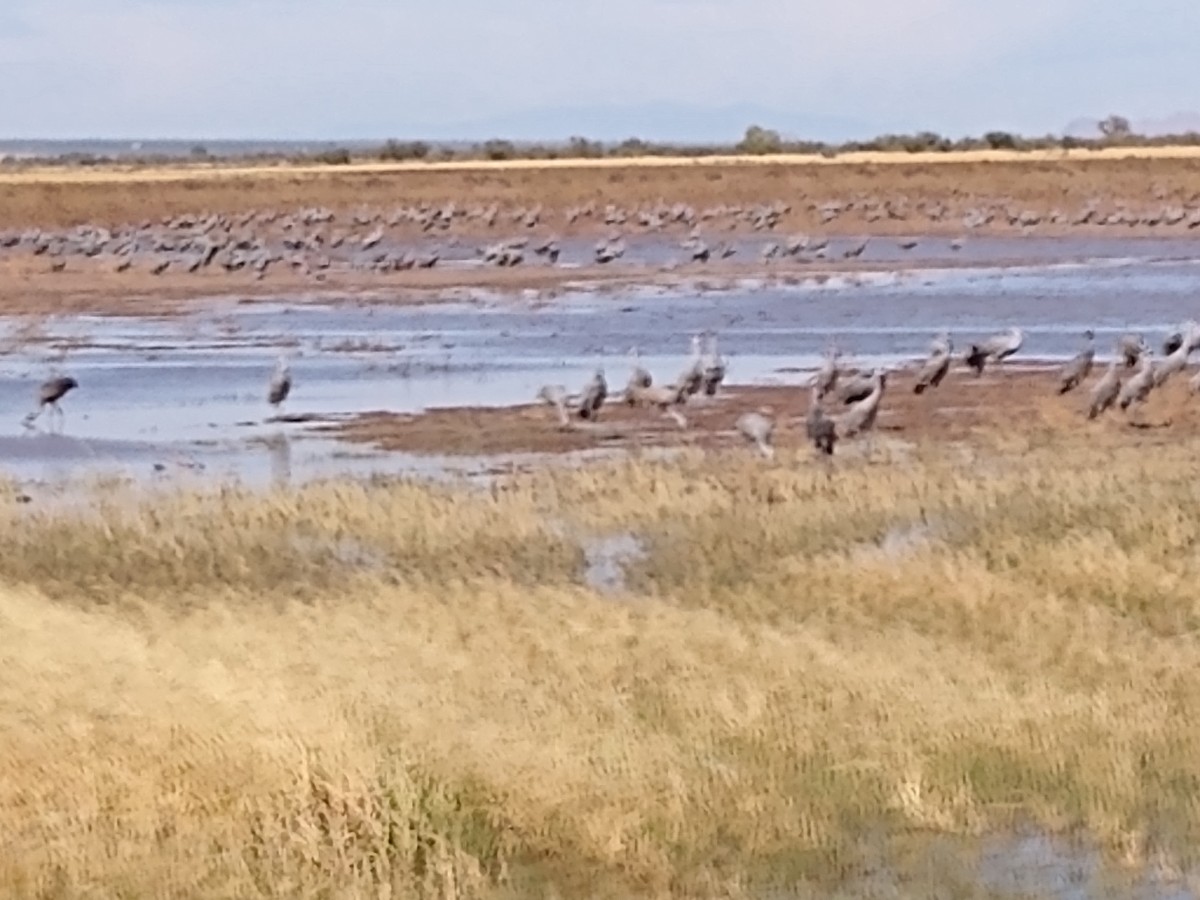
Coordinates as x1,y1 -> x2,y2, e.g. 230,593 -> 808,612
0,232 -> 1200,482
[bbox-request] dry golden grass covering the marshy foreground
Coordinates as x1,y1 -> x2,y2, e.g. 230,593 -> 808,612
7,438 -> 1200,898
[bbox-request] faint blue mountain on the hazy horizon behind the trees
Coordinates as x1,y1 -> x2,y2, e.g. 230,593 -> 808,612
408,103 -> 881,144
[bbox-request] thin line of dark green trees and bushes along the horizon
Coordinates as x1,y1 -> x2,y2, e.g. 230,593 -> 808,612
0,115 -> 1200,167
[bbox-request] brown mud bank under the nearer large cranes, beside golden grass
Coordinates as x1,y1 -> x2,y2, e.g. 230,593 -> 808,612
323,367 -> 1200,456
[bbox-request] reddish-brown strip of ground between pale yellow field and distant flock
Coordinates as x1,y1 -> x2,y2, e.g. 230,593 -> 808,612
7,156 -> 1200,234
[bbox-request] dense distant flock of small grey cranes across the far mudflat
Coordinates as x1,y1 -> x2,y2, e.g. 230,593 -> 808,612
14,196 -> 1200,280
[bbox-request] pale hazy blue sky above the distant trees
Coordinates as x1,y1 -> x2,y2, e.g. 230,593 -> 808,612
0,0 -> 1200,139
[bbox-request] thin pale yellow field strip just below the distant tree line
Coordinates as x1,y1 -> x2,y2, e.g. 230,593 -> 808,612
7,146 -> 1200,184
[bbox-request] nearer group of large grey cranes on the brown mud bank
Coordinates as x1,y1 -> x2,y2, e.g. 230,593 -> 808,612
538,320 -> 1200,457
